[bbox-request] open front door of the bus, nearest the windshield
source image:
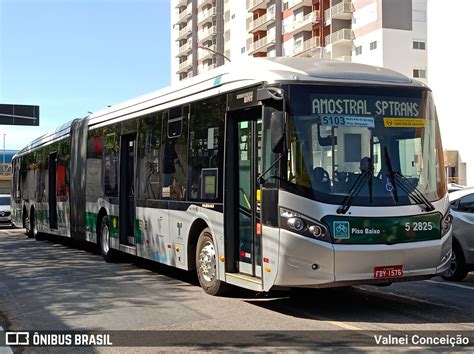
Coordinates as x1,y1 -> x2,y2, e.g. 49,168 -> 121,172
225,106 -> 262,278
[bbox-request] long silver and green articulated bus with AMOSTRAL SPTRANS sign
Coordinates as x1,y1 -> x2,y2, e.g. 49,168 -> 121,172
12,58 -> 451,295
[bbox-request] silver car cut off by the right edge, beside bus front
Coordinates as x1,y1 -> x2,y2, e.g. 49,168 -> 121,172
442,188 -> 474,281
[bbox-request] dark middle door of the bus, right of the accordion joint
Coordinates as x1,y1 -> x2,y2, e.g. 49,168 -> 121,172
119,133 -> 137,246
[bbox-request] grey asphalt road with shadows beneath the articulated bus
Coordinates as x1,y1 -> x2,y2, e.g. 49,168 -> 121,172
0,229 -> 474,353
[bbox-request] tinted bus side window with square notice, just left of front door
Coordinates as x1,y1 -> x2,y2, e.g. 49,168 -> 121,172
188,96 -> 225,201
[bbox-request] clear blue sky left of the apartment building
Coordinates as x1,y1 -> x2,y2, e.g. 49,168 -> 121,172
0,0 -> 171,149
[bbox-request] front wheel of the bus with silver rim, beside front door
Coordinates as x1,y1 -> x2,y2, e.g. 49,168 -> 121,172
196,228 -> 229,295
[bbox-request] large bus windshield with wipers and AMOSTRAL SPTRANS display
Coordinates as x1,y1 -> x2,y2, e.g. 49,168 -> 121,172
283,84 -> 446,206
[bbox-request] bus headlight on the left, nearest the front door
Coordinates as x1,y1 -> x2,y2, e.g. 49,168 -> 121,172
280,208 -> 331,242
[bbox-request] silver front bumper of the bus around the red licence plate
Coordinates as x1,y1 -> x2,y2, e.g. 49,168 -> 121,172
274,230 -> 451,287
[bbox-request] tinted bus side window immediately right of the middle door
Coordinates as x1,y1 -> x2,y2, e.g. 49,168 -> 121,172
138,113 -> 163,199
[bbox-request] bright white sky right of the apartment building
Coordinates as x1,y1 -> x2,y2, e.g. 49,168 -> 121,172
427,0 -> 474,185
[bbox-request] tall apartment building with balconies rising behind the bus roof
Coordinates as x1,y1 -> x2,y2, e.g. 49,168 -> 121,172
171,0 -> 427,81
